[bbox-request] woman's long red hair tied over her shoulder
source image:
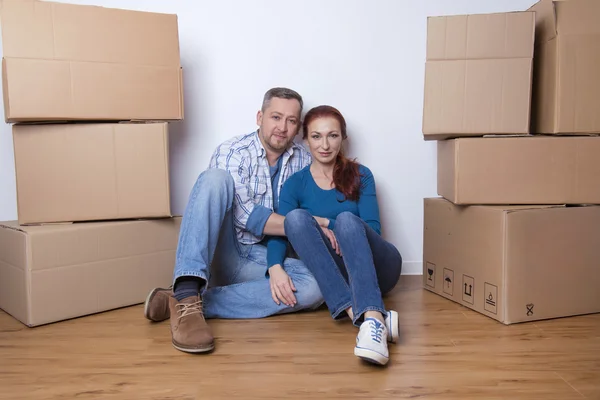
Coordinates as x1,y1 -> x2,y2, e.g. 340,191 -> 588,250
302,106 -> 360,201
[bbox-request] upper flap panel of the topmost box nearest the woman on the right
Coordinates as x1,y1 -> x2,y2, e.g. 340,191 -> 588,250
427,11 -> 535,61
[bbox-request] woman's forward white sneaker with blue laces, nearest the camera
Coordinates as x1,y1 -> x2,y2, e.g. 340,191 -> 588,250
354,318 -> 390,365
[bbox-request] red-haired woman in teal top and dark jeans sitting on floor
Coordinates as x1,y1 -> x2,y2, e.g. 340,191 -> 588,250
267,106 -> 402,365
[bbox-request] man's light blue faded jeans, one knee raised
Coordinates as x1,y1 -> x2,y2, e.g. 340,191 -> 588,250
173,169 -> 323,319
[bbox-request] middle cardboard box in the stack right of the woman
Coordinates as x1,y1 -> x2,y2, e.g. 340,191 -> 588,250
437,136 -> 600,205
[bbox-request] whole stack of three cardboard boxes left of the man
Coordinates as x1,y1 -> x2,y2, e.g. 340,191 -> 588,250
0,0 -> 183,326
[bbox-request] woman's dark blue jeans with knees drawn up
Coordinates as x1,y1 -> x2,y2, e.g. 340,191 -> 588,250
284,209 -> 402,326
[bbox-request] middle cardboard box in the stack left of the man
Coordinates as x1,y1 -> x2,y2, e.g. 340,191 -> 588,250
13,122 -> 171,224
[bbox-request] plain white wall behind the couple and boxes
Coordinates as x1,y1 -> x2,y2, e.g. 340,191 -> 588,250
0,0 -> 535,274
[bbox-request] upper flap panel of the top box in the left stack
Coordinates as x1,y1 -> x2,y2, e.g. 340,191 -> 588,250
1,0 -> 180,67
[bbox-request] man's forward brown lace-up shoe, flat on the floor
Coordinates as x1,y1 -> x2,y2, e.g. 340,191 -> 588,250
169,296 -> 215,353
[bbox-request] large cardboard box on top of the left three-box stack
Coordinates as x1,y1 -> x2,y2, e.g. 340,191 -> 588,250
0,0 -> 183,122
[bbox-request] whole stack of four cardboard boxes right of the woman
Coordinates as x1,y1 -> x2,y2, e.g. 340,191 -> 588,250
423,0 -> 600,324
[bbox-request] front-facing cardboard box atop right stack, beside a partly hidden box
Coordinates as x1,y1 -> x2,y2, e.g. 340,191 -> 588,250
423,12 -> 535,140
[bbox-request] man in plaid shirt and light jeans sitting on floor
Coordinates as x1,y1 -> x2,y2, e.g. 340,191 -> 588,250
144,88 -> 323,353
